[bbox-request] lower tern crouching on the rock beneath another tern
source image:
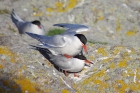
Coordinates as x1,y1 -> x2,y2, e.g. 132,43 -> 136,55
30,45 -> 92,77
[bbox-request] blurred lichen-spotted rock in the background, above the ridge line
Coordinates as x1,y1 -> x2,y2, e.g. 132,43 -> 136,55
0,0 -> 140,46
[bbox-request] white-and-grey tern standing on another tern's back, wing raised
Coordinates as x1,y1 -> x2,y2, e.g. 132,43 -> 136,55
26,23 -> 89,58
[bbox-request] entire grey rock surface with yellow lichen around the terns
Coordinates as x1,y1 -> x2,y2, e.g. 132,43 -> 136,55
0,0 -> 140,93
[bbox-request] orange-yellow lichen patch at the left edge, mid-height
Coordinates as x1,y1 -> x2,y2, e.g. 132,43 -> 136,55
0,46 -> 17,62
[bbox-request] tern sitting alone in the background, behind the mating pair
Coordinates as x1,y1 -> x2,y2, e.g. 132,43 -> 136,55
11,9 -> 45,35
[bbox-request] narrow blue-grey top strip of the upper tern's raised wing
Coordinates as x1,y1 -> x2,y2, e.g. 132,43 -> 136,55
53,23 -> 88,29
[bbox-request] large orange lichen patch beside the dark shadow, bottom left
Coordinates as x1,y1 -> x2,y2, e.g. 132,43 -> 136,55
15,78 -> 37,93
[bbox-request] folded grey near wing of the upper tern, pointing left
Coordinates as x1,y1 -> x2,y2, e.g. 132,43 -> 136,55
26,32 -> 66,47
